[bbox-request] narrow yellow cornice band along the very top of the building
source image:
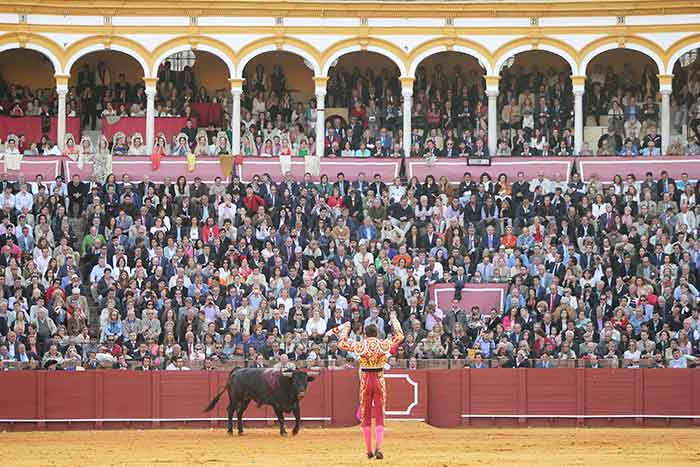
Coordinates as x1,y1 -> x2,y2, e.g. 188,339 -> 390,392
8,0 -> 700,18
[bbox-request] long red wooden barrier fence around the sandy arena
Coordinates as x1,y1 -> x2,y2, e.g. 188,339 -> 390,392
0,368 -> 700,429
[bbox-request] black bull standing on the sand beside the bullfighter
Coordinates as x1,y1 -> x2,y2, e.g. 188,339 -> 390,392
204,368 -> 314,436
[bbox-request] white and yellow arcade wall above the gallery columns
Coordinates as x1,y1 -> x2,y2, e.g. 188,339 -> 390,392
0,6 -> 700,83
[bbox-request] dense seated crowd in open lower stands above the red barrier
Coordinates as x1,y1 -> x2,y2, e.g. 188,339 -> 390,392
0,157 -> 700,369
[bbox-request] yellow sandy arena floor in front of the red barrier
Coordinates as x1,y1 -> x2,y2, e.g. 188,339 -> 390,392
0,422 -> 700,467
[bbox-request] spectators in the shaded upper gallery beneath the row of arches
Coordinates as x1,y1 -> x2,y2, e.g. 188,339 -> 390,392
0,57 -> 700,159
